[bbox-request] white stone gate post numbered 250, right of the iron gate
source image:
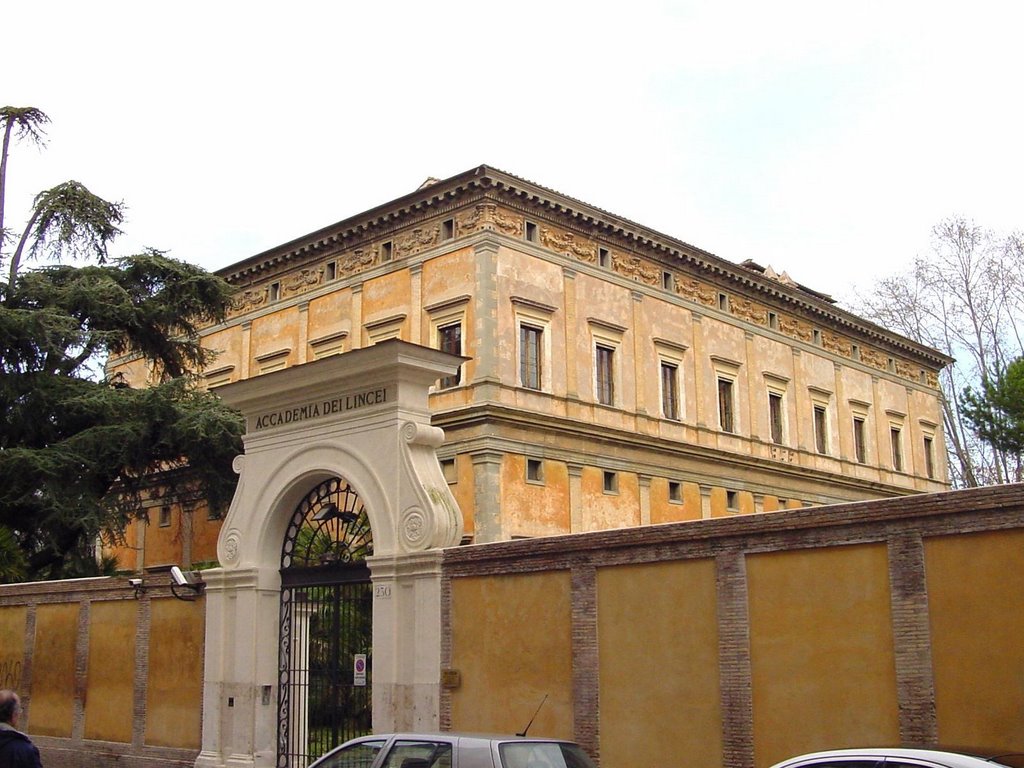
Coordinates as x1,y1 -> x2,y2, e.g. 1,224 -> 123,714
367,550 -> 443,733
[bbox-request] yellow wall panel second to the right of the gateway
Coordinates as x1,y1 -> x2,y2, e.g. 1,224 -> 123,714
597,560 -> 722,768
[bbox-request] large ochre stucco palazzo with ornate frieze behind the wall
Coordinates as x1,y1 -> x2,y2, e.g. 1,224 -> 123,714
112,166 -> 950,569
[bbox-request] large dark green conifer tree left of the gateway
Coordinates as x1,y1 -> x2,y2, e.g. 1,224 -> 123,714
0,108 -> 244,581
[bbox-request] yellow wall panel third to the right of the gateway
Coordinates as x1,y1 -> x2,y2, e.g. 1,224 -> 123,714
746,544 -> 899,766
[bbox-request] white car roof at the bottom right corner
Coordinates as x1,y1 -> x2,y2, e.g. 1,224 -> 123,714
772,748 -> 1024,768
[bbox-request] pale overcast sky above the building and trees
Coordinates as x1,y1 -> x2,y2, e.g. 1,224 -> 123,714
0,0 -> 1024,309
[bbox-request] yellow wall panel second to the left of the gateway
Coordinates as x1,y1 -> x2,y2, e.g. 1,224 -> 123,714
85,600 -> 138,743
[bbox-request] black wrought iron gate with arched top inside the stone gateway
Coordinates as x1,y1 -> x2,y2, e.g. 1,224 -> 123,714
278,478 -> 373,768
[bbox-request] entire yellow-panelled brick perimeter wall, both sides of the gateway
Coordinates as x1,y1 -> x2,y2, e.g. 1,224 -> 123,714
0,485 -> 1024,768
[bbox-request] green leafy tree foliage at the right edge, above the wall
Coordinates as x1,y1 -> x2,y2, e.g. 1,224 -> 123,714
961,357 -> 1024,457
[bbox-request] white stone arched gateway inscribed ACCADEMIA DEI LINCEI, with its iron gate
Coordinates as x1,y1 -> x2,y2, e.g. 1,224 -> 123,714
196,340 -> 465,768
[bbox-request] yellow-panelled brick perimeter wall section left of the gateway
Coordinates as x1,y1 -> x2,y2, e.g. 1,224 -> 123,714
0,573 -> 206,768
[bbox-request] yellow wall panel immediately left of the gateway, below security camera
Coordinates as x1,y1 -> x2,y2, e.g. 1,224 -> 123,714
145,598 -> 206,749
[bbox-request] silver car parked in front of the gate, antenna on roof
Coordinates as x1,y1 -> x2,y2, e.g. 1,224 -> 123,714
309,733 -> 595,768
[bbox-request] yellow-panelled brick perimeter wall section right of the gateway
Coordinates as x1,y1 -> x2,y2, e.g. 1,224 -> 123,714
441,485 -> 1024,768
